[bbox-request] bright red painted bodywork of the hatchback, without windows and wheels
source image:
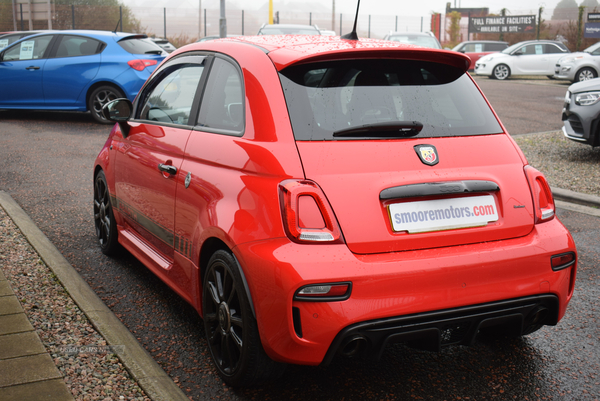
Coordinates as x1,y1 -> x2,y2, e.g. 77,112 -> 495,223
94,36 -> 576,384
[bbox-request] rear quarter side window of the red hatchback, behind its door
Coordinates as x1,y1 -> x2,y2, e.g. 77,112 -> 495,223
198,58 -> 244,133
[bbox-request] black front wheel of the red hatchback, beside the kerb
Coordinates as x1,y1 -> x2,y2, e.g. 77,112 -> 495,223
94,171 -> 122,256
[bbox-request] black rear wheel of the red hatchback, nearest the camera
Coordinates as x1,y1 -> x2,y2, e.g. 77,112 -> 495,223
202,250 -> 284,387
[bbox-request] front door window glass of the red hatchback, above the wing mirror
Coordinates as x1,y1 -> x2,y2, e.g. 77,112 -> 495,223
139,63 -> 204,125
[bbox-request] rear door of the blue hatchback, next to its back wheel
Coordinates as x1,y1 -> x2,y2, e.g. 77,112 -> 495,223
43,35 -> 106,107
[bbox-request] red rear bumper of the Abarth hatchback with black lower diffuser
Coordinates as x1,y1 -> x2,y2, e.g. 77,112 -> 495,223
234,219 -> 577,365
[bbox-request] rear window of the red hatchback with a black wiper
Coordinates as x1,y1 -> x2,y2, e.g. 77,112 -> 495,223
280,59 -> 502,141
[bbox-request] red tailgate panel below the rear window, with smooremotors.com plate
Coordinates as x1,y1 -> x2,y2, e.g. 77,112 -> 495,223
297,134 -> 534,254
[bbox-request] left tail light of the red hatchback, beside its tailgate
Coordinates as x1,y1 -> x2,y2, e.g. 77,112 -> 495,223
279,180 -> 343,244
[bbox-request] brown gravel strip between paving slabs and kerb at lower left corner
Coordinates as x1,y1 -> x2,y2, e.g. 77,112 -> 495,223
0,208 -> 150,400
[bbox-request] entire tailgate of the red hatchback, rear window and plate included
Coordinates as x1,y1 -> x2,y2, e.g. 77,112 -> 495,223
280,52 -> 534,254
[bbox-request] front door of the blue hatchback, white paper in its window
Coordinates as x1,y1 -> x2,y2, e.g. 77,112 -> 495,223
0,35 -> 55,108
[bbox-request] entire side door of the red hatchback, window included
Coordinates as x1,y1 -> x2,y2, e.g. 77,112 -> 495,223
115,56 -> 207,284
